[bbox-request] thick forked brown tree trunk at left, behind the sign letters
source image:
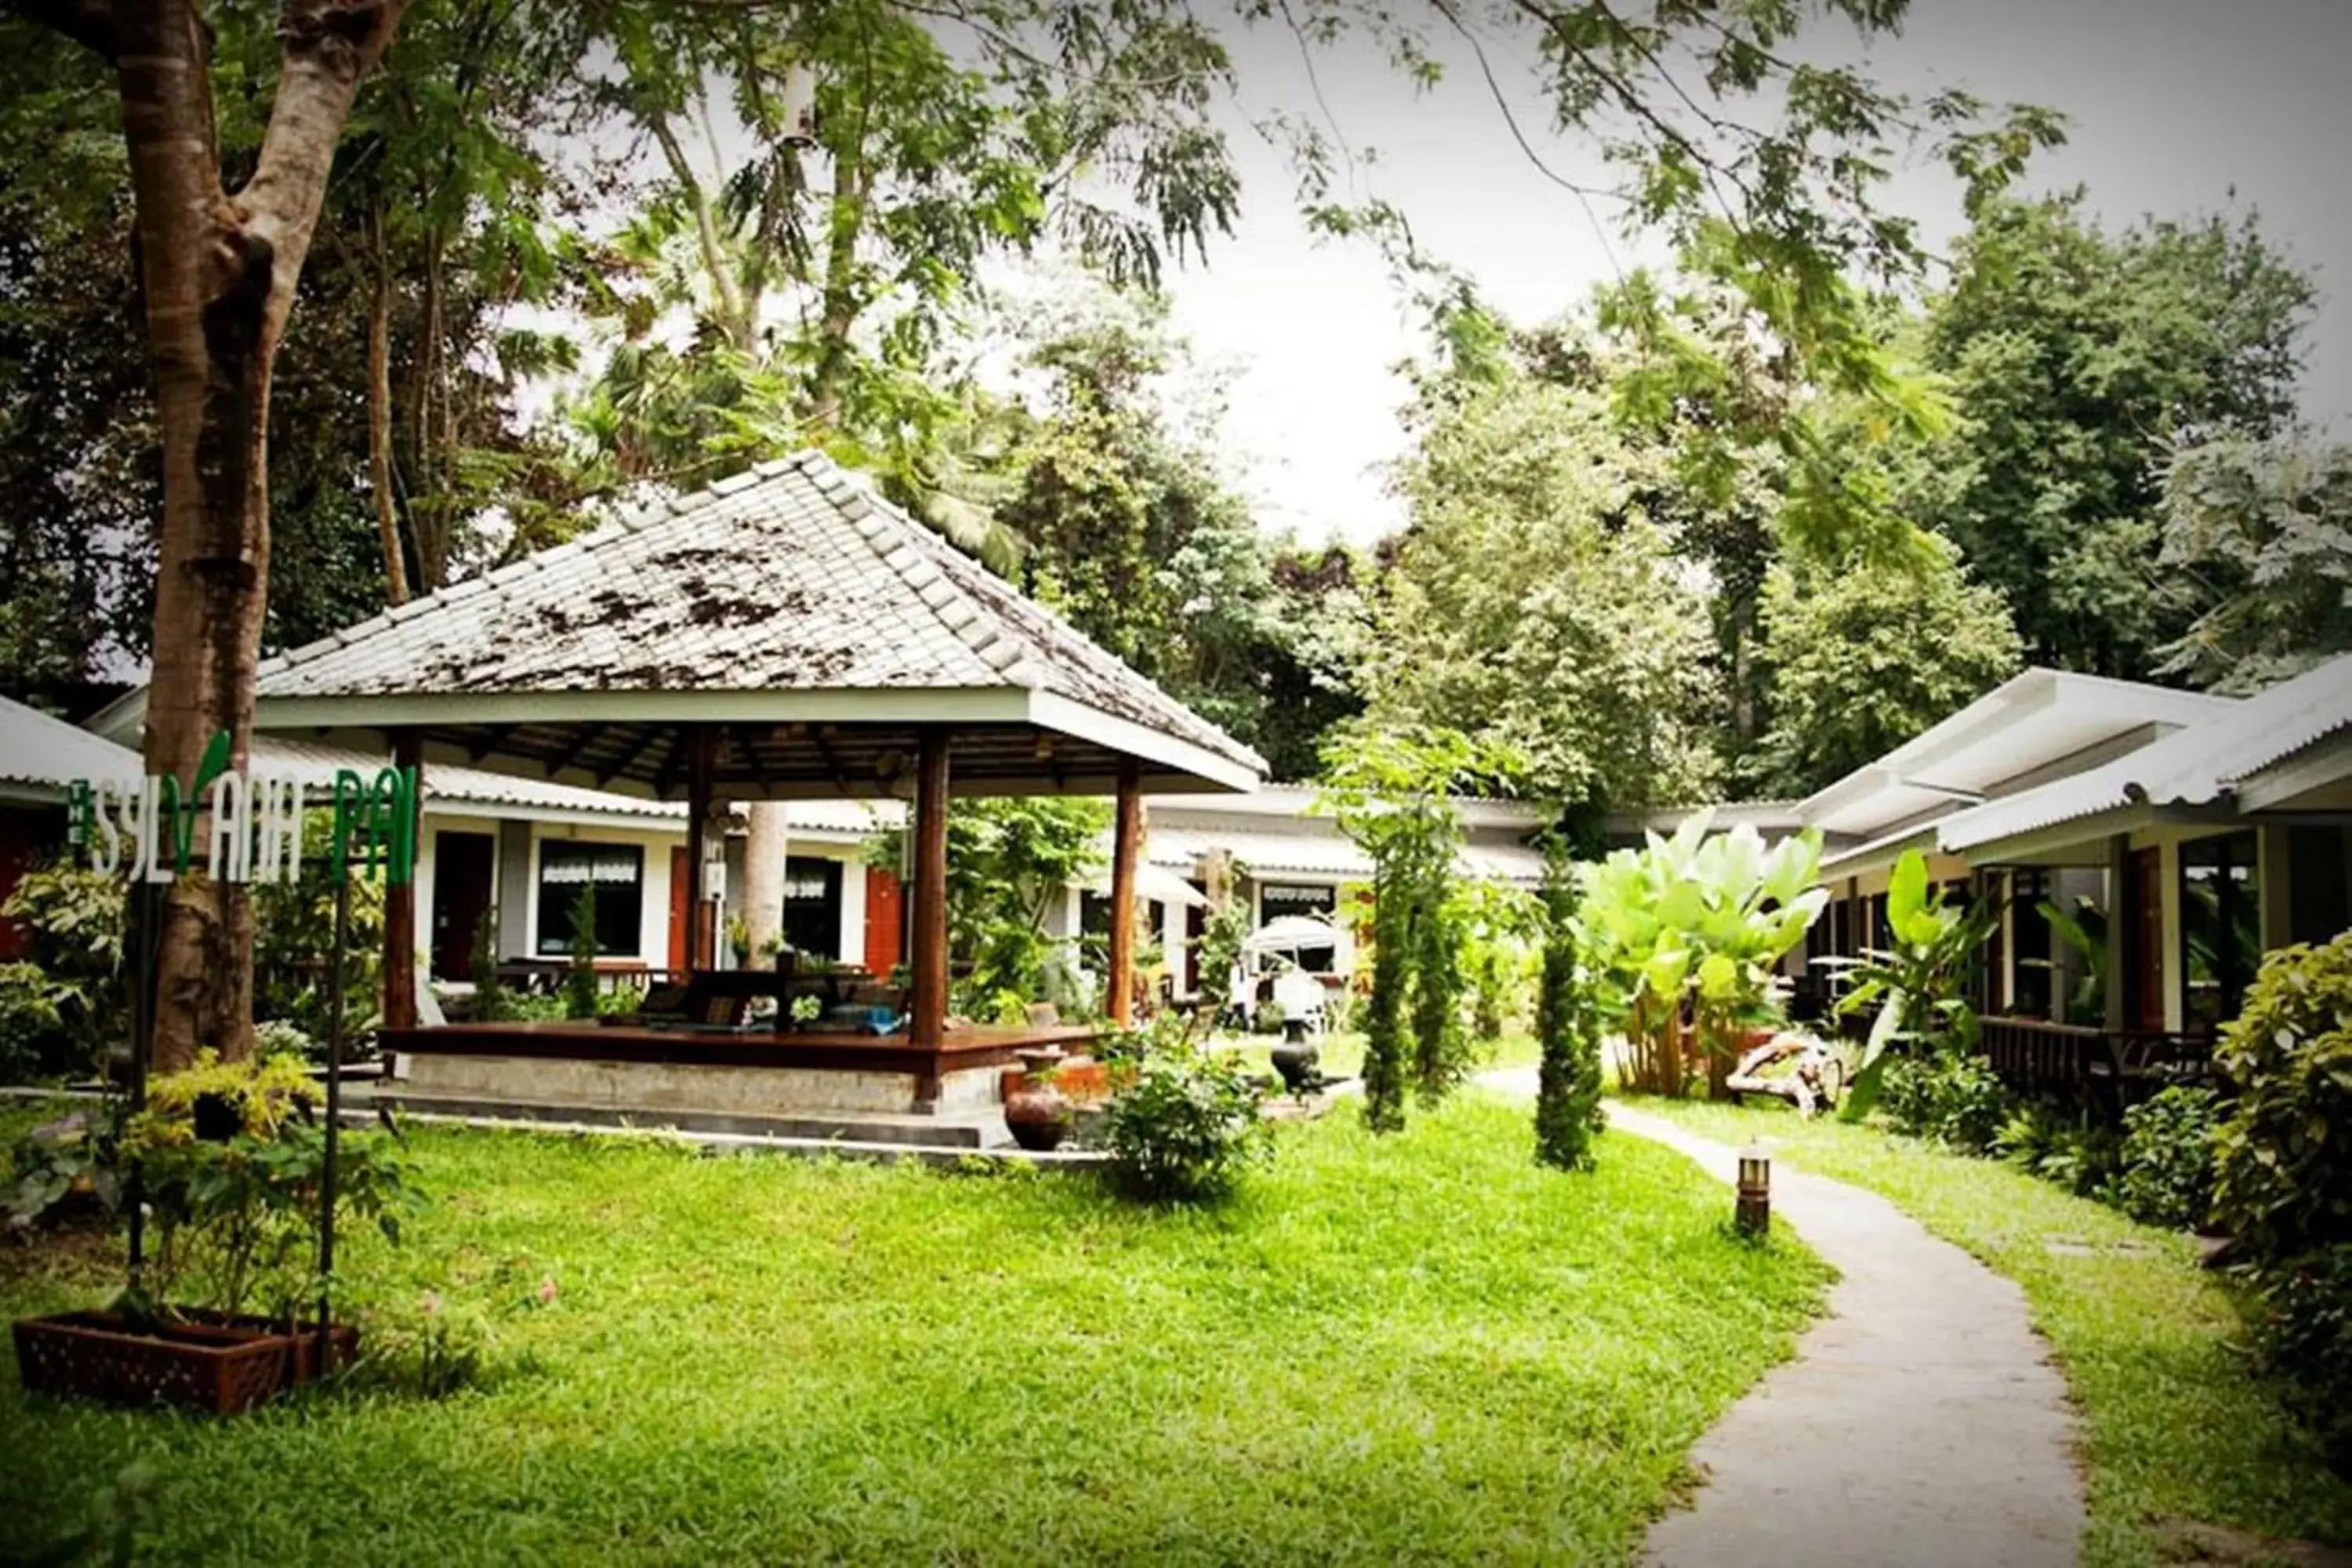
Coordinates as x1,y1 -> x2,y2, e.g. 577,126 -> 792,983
82,0 -> 405,1069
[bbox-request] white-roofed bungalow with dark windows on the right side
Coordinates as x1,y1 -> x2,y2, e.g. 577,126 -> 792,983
1759,659 -> 2352,1086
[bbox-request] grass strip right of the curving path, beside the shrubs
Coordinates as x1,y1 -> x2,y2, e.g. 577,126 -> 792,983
1639,1100 -> 2352,1566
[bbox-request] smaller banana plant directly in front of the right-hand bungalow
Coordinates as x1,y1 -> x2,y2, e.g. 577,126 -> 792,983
1837,848 -> 1999,1121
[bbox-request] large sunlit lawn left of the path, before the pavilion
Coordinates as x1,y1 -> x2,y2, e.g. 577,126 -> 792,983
0,1095 -> 1828,1566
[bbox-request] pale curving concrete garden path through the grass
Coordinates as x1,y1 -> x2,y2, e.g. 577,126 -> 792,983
1486,1069 -> 2084,1568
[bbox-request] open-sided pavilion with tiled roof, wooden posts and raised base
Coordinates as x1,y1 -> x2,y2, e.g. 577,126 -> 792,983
114,452 -> 1265,1128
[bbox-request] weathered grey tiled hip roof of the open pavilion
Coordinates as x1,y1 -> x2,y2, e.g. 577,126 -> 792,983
259,454 -> 1263,771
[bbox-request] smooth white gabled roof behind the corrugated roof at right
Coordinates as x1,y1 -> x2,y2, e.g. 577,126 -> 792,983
1799,668 -> 2234,837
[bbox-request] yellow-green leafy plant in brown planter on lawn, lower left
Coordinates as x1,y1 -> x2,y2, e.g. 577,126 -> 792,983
14,1051 -> 416,1413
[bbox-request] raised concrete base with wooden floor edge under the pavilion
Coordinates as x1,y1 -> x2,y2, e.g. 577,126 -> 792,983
376,1022 -> 1094,1147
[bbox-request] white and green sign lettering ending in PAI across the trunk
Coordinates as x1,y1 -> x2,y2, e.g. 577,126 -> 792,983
66,729 -> 416,884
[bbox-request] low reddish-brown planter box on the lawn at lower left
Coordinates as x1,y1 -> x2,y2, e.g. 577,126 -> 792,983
14,1309 -> 360,1415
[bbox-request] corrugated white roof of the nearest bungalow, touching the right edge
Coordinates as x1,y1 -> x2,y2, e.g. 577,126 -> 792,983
1938,656 -> 2352,848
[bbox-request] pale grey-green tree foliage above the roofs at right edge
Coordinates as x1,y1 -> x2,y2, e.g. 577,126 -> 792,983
2157,435 -> 2352,696
